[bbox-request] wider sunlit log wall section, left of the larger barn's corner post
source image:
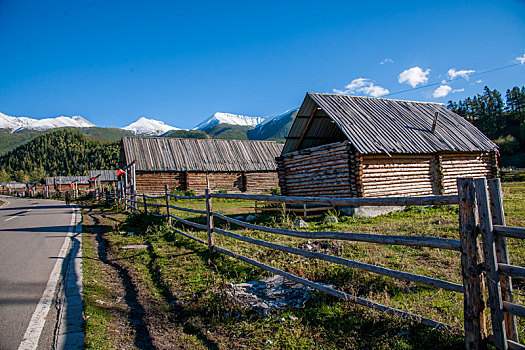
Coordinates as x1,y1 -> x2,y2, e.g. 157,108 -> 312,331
362,154 -> 436,197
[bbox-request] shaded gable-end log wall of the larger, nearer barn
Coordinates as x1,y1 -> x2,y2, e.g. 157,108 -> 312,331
276,142 -> 359,197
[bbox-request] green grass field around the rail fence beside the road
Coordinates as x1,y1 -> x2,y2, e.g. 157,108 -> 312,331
84,182 -> 525,349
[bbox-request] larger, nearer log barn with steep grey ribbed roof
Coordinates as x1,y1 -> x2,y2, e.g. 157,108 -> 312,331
277,93 -> 498,197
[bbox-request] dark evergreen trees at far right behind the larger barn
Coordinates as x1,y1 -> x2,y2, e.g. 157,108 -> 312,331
447,86 -> 525,168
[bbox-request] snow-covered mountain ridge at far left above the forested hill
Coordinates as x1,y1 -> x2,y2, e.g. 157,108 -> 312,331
0,113 -> 95,132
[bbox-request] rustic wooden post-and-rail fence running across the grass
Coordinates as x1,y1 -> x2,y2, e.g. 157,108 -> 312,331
116,178 -> 525,350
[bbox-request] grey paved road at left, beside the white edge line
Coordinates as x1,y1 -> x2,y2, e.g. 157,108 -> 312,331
0,197 -> 75,350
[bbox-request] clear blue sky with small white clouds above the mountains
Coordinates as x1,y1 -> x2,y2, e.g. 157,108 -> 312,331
0,0 -> 525,128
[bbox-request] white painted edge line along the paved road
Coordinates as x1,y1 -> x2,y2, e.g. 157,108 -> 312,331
18,209 -> 77,350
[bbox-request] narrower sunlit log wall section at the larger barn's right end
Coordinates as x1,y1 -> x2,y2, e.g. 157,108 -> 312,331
442,152 -> 498,195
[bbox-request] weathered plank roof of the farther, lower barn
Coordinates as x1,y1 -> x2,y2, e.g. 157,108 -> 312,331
122,137 -> 283,172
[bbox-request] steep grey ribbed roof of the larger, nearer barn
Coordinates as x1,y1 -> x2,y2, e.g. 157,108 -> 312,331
283,93 -> 497,154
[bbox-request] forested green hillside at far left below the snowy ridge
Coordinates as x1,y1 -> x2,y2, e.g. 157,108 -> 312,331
0,129 -> 119,182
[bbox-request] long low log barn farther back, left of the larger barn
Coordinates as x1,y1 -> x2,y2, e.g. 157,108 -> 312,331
120,137 -> 283,193
